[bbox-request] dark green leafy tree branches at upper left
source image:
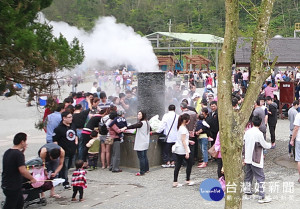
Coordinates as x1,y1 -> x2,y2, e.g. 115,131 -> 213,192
0,0 -> 84,93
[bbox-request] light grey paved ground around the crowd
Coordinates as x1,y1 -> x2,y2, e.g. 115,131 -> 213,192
0,79 -> 300,209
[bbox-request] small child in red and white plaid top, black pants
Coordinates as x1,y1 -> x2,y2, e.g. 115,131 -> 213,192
72,160 -> 87,202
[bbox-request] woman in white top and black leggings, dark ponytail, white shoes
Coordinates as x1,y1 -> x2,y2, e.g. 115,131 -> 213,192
172,113 -> 194,187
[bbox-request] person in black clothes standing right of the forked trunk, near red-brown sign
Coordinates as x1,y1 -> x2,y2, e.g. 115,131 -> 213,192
266,96 -> 277,149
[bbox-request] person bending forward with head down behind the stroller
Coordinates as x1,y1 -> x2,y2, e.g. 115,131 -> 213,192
38,143 -> 65,199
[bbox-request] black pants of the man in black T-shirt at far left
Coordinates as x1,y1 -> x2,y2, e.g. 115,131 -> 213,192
3,189 -> 24,209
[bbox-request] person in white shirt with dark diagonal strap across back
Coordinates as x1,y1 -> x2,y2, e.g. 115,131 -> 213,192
156,104 -> 178,168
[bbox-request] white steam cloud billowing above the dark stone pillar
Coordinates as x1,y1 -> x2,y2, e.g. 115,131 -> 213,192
39,14 -> 158,72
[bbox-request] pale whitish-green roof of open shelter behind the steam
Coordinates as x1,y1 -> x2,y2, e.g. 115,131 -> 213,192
145,32 -> 224,44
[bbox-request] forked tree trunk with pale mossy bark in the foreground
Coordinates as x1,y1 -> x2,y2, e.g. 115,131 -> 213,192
218,0 -> 276,209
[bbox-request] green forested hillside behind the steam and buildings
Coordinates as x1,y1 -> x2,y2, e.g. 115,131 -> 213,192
43,0 -> 300,37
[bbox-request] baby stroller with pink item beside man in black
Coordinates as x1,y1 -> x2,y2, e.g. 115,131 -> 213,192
22,158 -> 53,208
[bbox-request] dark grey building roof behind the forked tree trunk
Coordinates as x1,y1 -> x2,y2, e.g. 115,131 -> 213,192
234,38 -> 300,66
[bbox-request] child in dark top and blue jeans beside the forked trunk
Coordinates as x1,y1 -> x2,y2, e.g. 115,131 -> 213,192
195,114 -> 210,168
